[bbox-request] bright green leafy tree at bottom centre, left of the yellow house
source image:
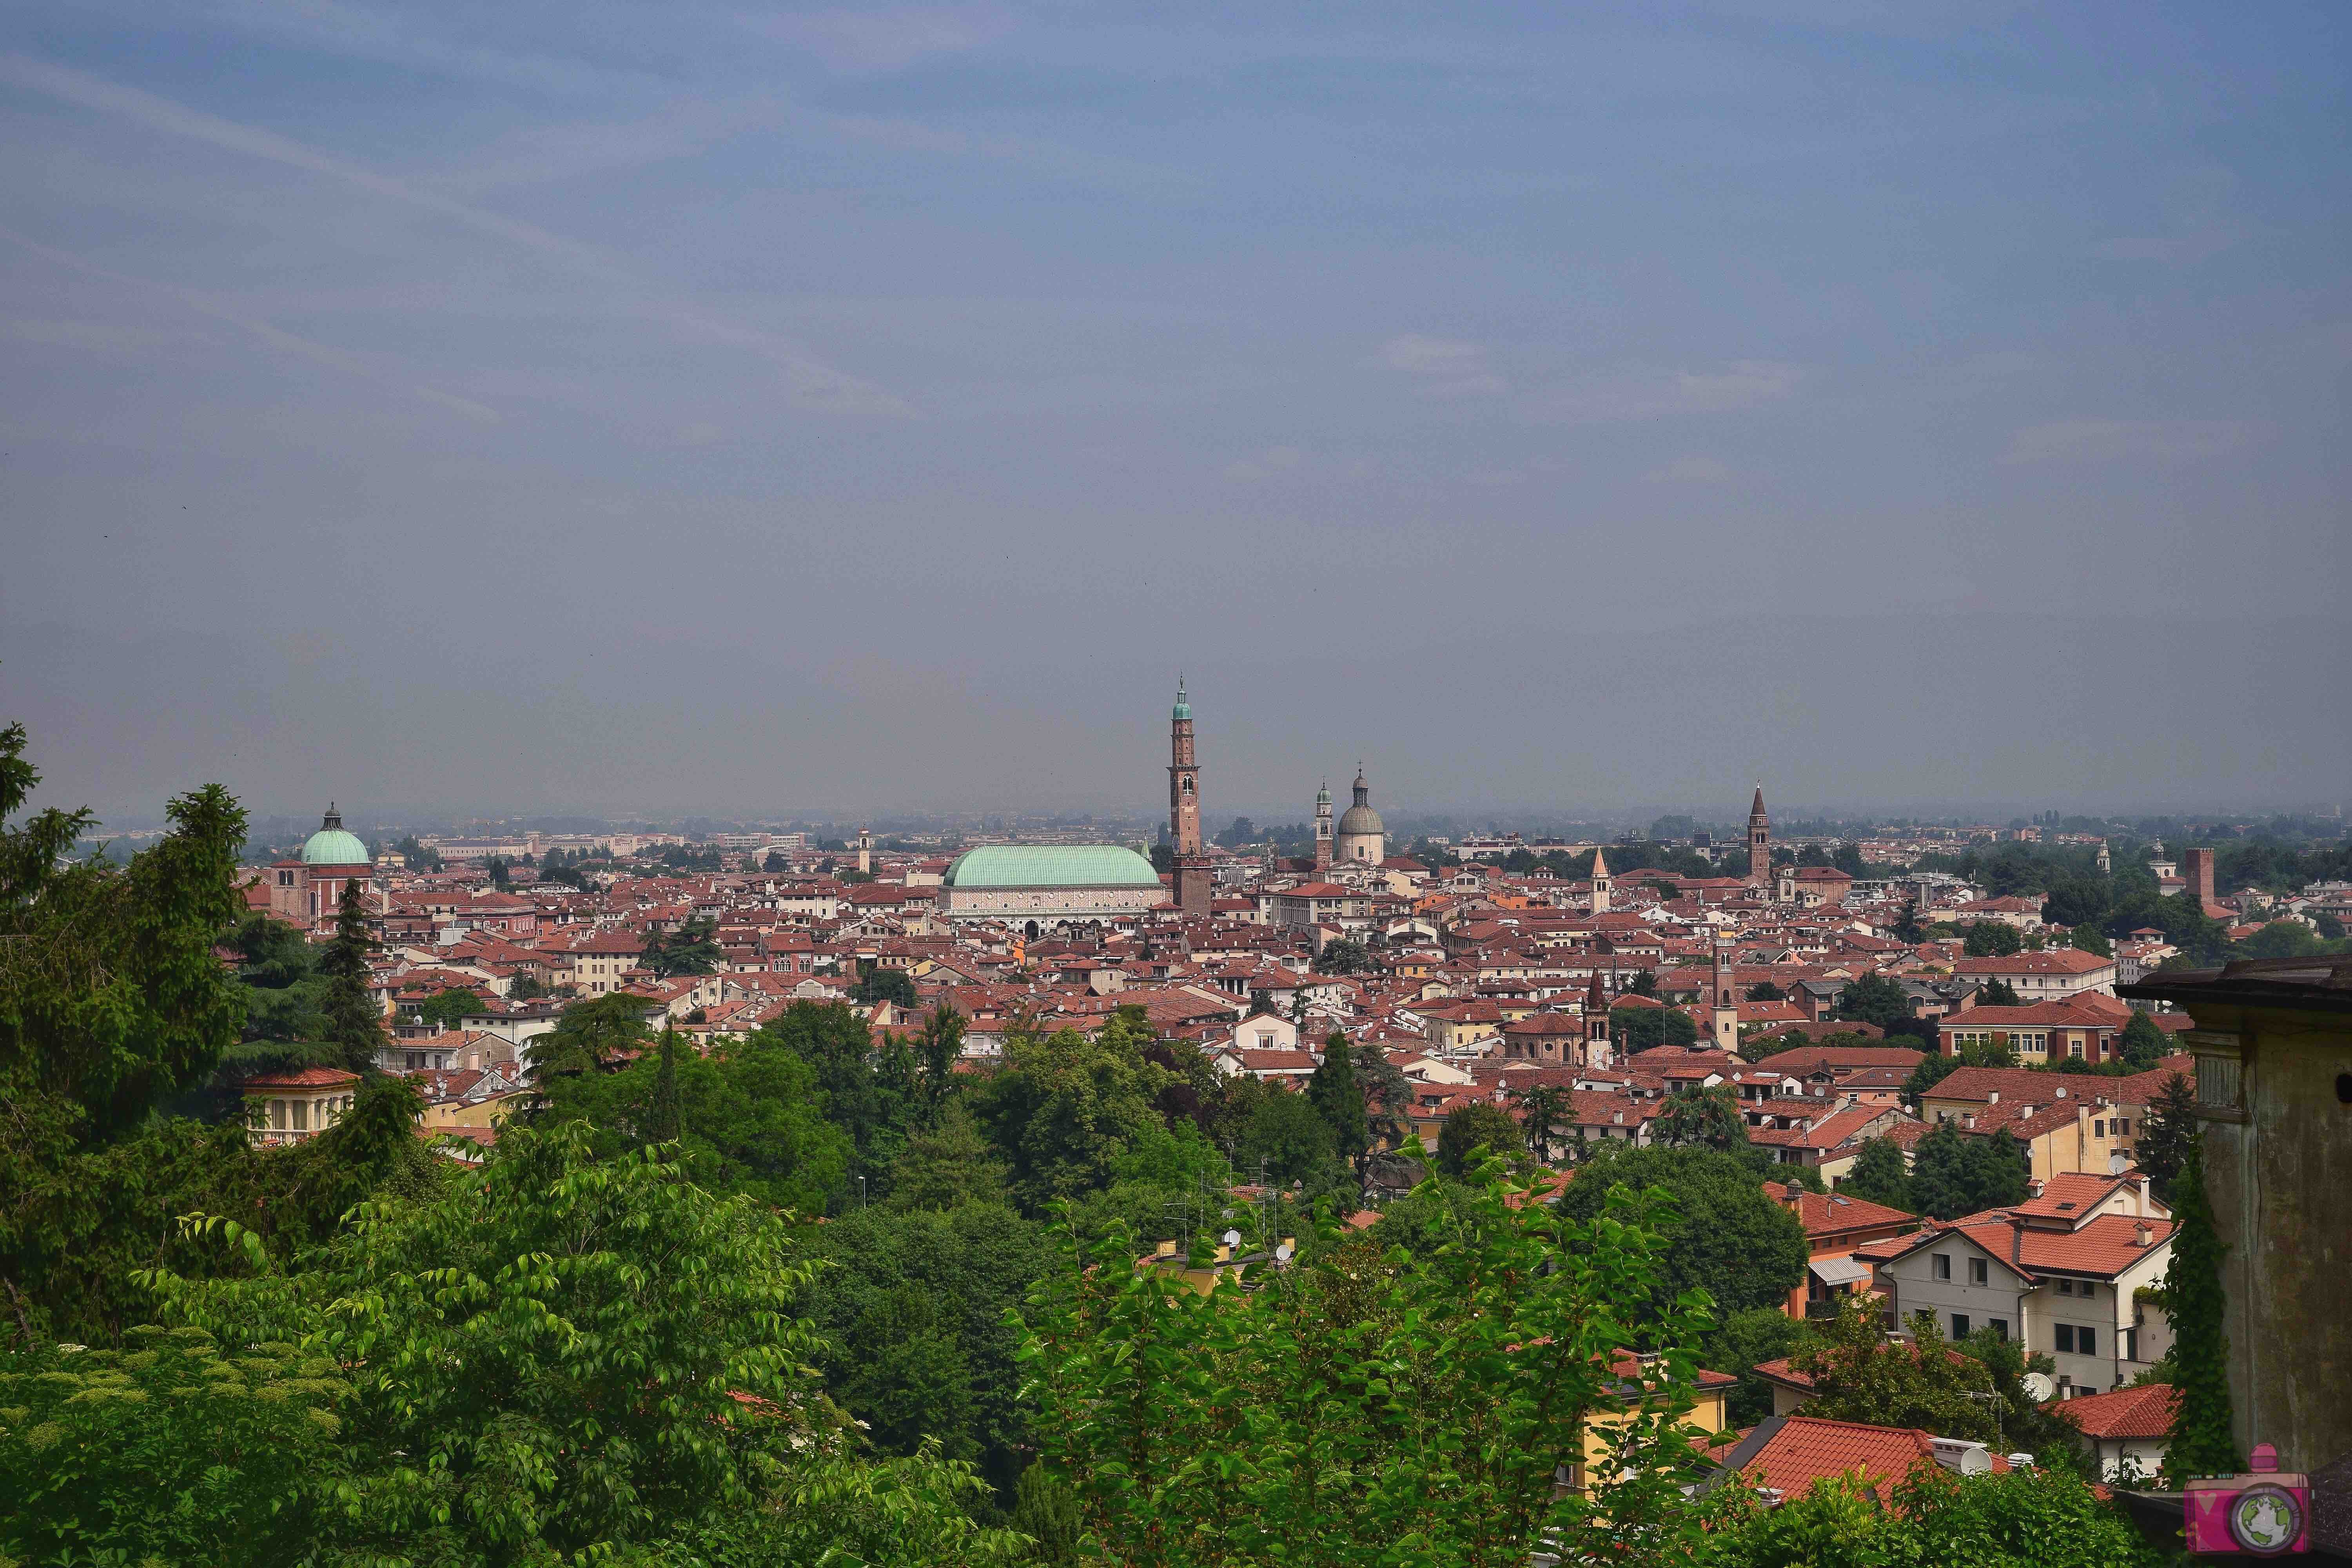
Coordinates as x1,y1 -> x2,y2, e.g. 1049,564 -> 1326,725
1025,1171 -> 1700,1568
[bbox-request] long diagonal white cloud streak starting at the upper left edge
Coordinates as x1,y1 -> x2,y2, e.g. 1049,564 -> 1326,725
0,54 -> 908,414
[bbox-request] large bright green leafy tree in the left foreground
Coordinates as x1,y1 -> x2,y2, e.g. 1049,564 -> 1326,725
146,1124 -> 1011,1563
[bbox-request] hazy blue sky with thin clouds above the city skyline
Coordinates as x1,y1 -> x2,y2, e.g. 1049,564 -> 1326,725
0,0 -> 2352,820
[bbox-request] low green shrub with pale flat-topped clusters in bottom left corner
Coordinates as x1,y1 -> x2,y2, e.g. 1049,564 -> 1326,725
0,1326 -> 350,1568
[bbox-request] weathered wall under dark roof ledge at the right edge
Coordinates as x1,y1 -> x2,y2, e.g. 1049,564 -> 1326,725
2187,1004 -> 2352,1469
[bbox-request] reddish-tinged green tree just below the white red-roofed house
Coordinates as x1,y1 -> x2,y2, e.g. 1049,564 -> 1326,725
1790,1293 -> 1997,1443
